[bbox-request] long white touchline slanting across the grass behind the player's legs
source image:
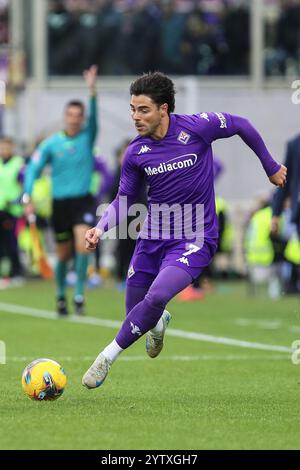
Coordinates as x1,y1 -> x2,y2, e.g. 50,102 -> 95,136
0,302 -> 293,353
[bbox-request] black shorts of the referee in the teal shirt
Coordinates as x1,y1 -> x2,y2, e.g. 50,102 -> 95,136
52,195 -> 95,243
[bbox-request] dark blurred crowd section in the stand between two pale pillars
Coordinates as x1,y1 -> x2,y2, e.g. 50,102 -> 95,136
48,0 -> 249,75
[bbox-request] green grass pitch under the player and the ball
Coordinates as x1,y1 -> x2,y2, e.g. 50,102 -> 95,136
0,281 -> 300,450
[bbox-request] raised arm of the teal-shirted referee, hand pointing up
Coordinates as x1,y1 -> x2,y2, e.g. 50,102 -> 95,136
83,65 -> 98,145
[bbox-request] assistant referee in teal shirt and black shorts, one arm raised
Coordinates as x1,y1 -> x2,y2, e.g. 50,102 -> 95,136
23,66 -> 97,315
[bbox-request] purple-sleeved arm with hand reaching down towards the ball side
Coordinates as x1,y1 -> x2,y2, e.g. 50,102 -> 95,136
85,150 -> 143,250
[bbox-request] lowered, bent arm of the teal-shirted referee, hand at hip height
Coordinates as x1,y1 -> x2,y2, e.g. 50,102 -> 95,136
22,142 -> 51,215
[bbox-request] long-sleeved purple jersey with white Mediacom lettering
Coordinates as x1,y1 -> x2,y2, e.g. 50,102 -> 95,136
98,112 -> 280,239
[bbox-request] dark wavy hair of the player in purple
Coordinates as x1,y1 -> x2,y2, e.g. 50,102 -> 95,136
130,72 -> 176,114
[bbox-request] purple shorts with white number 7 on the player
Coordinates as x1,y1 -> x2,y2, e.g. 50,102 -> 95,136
127,238 -> 218,287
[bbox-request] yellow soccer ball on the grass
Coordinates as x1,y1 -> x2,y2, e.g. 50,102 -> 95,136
22,359 -> 67,401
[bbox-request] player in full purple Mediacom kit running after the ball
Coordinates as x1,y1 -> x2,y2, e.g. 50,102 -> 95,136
82,72 -> 287,388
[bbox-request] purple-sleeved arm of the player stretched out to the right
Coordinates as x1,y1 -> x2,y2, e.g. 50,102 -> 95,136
200,113 -> 287,187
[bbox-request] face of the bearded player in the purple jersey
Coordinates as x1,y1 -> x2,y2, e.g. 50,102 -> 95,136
130,95 -> 168,136
